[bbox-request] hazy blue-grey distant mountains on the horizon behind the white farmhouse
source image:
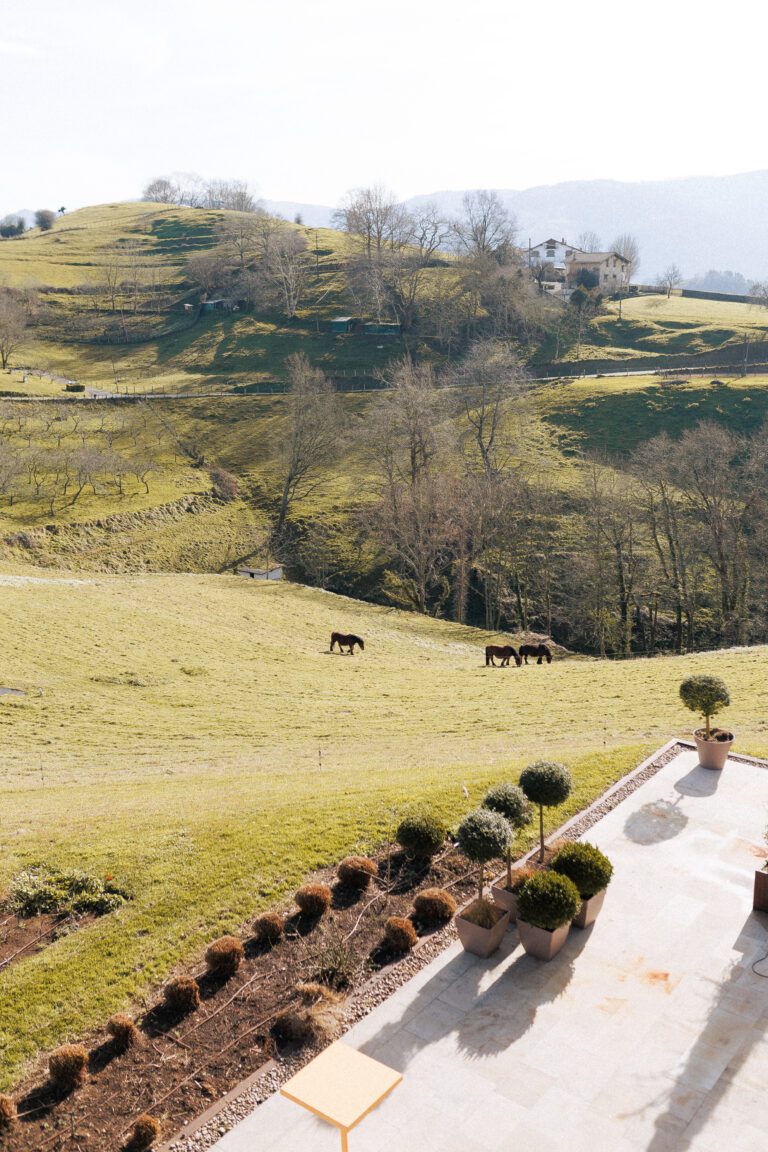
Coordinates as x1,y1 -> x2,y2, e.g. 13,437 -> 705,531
265,170 -> 768,282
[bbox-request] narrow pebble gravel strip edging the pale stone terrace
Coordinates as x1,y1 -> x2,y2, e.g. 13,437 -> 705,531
162,740 -> 768,1152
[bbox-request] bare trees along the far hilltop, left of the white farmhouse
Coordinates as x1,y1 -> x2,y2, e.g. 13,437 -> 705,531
143,176 -> 639,355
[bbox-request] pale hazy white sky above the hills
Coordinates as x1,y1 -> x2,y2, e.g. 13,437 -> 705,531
0,0 -> 768,214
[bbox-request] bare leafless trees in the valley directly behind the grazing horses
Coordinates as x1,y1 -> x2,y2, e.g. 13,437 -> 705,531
272,338 -> 768,657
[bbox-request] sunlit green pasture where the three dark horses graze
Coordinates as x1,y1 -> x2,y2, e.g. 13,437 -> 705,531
0,576 -> 768,1085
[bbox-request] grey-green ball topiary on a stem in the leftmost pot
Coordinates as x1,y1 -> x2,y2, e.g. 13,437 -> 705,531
456,808 -> 512,958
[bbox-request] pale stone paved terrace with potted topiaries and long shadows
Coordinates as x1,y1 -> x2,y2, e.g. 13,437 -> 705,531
210,751 -> 768,1152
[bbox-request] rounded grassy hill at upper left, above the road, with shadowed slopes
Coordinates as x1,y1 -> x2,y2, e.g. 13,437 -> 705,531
0,204 -> 416,392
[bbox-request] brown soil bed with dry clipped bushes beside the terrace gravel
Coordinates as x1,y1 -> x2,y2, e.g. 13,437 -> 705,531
0,850 -> 476,1152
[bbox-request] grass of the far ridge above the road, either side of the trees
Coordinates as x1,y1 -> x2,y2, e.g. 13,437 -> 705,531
0,203 -> 768,392
